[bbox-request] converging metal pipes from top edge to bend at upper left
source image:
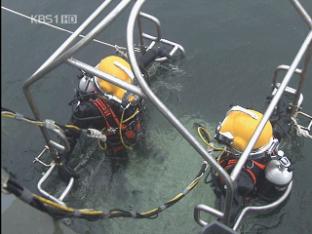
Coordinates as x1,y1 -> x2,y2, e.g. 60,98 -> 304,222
23,0 -> 131,146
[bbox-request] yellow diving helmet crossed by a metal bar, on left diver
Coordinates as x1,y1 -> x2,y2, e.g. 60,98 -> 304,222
95,55 -> 134,103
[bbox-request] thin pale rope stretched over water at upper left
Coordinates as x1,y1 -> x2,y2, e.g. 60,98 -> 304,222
1,6 -> 140,52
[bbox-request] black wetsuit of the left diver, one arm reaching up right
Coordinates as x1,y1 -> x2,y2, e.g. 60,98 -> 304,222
66,48 -> 168,158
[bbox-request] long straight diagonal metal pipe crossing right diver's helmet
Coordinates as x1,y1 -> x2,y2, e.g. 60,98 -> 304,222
231,30 -> 312,181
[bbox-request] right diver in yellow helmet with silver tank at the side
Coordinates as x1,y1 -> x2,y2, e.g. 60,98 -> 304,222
199,106 -> 293,223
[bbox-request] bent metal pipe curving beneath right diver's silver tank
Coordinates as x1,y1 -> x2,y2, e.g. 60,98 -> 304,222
233,182 -> 293,231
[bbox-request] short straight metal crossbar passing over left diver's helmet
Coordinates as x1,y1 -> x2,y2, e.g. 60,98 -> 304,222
67,58 -> 144,97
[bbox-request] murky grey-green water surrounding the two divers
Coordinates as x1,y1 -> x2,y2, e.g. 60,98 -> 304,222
1,0 -> 312,234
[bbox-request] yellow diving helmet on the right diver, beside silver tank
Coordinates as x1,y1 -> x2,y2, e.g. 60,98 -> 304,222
216,106 -> 273,154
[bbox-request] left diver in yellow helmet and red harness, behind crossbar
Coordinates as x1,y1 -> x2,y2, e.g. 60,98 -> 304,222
59,48 -> 169,174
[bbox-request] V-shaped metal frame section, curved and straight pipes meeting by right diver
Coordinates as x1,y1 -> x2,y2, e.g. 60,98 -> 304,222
127,0 -> 312,229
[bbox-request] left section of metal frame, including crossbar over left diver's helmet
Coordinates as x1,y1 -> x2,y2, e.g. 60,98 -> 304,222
23,0 -> 184,204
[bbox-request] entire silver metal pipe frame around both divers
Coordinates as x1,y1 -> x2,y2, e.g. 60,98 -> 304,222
23,0 -> 312,229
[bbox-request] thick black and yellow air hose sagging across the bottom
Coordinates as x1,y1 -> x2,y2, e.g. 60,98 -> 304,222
1,162 -> 208,221
